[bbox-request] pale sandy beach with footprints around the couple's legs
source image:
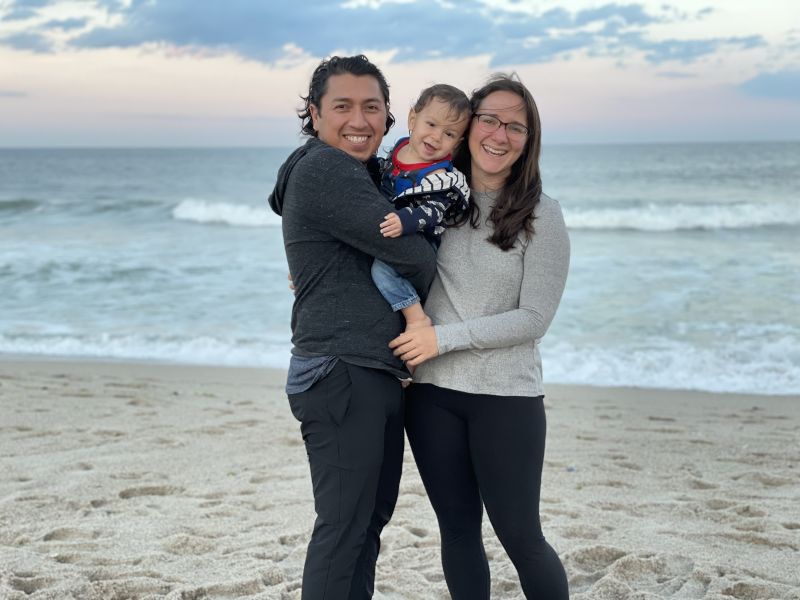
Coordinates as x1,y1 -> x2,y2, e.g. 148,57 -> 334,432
0,359 -> 800,600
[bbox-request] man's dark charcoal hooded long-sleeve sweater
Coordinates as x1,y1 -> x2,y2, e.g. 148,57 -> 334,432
269,138 -> 436,375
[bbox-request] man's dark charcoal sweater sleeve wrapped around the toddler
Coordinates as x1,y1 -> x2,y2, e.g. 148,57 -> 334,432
286,148 -> 436,299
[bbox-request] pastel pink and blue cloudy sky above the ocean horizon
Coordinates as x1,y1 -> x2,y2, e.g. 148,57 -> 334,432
0,0 -> 800,147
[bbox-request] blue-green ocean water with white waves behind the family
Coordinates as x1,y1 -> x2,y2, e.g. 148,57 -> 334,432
0,143 -> 800,394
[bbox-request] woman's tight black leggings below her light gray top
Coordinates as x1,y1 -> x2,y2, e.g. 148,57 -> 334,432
406,384 -> 569,600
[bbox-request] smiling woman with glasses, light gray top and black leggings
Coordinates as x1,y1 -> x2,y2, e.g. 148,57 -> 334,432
390,75 -> 569,600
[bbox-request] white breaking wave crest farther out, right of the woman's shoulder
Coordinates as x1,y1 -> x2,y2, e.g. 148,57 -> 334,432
563,203 -> 800,231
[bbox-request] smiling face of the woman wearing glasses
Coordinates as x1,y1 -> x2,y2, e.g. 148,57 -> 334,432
469,91 -> 530,191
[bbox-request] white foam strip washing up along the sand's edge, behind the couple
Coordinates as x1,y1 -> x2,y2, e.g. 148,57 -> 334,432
0,331 -> 800,394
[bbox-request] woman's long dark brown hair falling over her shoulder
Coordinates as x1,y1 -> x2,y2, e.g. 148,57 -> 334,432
453,73 -> 542,250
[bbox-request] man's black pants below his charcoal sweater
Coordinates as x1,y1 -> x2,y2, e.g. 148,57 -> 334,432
289,360 -> 403,600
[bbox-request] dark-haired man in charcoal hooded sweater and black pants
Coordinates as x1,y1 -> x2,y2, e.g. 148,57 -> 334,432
269,56 -> 435,600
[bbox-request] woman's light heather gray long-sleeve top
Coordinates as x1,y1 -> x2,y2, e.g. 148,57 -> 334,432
414,192 -> 570,396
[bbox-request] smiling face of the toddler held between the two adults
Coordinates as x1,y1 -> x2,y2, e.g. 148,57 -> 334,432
408,98 -> 469,162
